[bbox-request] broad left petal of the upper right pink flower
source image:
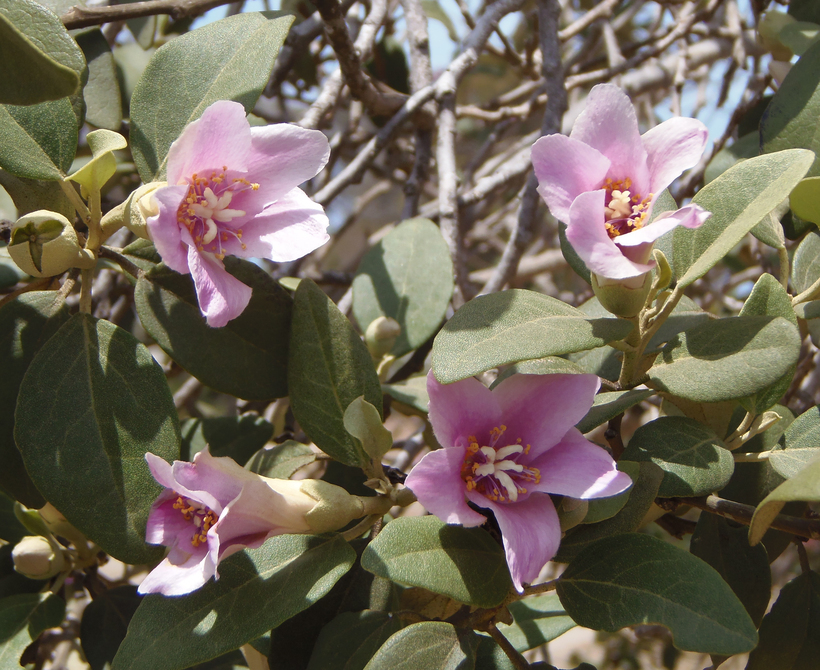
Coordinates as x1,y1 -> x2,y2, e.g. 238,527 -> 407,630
532,134 -> 611,223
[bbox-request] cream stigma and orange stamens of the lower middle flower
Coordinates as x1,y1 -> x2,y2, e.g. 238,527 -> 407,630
461,425 -> 541,502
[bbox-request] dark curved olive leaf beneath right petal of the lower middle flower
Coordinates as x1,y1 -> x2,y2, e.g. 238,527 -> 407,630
552,460 -> 664,563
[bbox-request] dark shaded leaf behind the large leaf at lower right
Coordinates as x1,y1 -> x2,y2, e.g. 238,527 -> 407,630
689,512 -> 772,627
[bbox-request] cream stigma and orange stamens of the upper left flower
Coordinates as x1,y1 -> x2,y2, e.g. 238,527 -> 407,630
177,166 -> 259,260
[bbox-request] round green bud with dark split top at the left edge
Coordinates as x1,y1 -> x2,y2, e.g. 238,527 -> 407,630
8,209 -> 97,277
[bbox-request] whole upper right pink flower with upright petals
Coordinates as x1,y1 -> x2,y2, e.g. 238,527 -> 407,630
532,84 -> 711,279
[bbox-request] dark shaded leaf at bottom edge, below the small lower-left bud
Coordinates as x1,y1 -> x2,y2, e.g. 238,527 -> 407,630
80,584 -> 142,670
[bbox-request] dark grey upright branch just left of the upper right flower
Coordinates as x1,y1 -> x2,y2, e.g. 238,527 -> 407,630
481,0 -> 567,293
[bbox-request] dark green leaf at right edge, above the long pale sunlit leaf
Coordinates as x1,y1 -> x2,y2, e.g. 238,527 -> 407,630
760,38 -> 820,177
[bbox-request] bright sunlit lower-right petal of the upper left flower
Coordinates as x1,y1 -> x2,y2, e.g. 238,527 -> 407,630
225,188 -> 330,263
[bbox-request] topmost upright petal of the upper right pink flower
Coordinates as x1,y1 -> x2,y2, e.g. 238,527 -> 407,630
570,84 -> 650,195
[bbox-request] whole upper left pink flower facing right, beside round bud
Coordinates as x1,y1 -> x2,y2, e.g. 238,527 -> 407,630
148,100 -> 330,327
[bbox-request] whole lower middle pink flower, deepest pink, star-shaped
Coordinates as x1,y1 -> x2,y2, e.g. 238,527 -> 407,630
406,372 -> 632,591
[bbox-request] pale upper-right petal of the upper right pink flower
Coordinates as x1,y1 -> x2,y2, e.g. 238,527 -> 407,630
641,117 -> 709,195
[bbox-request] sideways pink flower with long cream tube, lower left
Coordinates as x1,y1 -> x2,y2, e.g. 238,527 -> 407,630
139,449 -> 362,596
